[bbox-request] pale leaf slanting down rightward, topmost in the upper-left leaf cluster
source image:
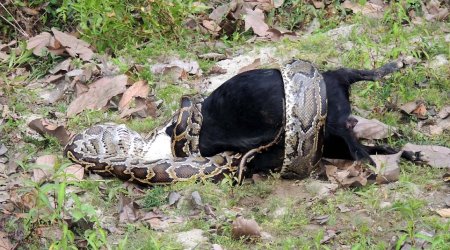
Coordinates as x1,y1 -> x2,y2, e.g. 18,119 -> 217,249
52,28 -> 94,61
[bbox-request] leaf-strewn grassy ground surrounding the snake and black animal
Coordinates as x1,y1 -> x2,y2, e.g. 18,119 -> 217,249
0,0 -> 450,249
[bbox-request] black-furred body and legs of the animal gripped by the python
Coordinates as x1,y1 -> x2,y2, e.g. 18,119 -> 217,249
167,63 -> 400,174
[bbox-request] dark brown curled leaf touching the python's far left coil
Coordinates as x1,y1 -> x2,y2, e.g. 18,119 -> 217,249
28,119 -> 72,145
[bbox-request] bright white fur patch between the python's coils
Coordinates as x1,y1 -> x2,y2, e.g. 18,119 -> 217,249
144,123 -> 173,161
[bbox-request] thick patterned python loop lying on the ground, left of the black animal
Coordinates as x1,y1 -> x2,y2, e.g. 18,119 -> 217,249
64,124 -> 241,185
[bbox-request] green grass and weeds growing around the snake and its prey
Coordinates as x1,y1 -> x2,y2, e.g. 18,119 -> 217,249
0,0 -> 450,249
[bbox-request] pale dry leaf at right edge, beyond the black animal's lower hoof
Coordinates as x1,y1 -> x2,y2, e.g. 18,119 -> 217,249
402,143 -> 450,168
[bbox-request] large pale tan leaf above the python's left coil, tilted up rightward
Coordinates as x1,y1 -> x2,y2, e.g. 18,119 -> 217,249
67,75 -> 128,117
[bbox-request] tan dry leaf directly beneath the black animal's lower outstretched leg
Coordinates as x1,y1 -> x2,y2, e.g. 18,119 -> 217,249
370,151 -> 403,184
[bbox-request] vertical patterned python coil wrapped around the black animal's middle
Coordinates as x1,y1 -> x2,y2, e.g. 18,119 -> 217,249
281,60 -> 327,178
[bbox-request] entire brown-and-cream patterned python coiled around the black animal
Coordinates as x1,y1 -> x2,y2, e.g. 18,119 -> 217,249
64,60 -> 327,185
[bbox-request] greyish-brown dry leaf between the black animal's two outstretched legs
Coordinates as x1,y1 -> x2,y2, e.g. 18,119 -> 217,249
353,115 -> 396,140
